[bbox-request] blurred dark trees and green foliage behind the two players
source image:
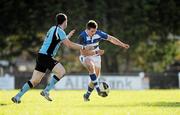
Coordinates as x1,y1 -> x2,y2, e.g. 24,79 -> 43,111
0,0 -> 180,73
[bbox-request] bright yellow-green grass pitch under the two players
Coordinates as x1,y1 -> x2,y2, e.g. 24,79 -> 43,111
0,90 -> 180,115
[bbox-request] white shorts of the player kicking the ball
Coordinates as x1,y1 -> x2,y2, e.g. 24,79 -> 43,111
79,55 -> 101,68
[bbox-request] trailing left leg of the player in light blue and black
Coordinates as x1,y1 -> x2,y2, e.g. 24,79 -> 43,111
11,70 -> 45,103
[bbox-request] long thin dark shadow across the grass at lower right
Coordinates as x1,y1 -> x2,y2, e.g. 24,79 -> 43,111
74,102 -> 180,108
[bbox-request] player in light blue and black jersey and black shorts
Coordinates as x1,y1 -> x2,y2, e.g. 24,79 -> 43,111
11,13 -> 104,103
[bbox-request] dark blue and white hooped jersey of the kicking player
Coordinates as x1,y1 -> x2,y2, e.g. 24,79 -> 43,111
79,30 -> 108,50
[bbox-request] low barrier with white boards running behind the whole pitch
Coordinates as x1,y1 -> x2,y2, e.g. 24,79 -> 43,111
0,72 -> 180,90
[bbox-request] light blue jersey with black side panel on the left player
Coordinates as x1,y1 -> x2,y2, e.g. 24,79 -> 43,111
39,26 -> 67,57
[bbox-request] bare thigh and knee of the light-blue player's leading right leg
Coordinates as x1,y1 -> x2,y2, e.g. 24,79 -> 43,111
52,63 -> 66,78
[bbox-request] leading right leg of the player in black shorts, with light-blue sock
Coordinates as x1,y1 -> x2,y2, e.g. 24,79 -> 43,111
40,63 -> 65,101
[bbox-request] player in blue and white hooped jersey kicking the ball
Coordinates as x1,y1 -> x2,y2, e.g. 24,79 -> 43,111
78,20 -> 129,101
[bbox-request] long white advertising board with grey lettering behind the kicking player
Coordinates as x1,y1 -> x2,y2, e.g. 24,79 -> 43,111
55,73 -> 149,90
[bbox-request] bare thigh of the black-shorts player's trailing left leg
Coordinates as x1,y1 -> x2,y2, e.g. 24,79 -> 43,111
30,70 -> 45,85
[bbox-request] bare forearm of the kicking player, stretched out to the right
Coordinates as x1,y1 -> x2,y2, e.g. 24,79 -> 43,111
107,35 -> 129,49
